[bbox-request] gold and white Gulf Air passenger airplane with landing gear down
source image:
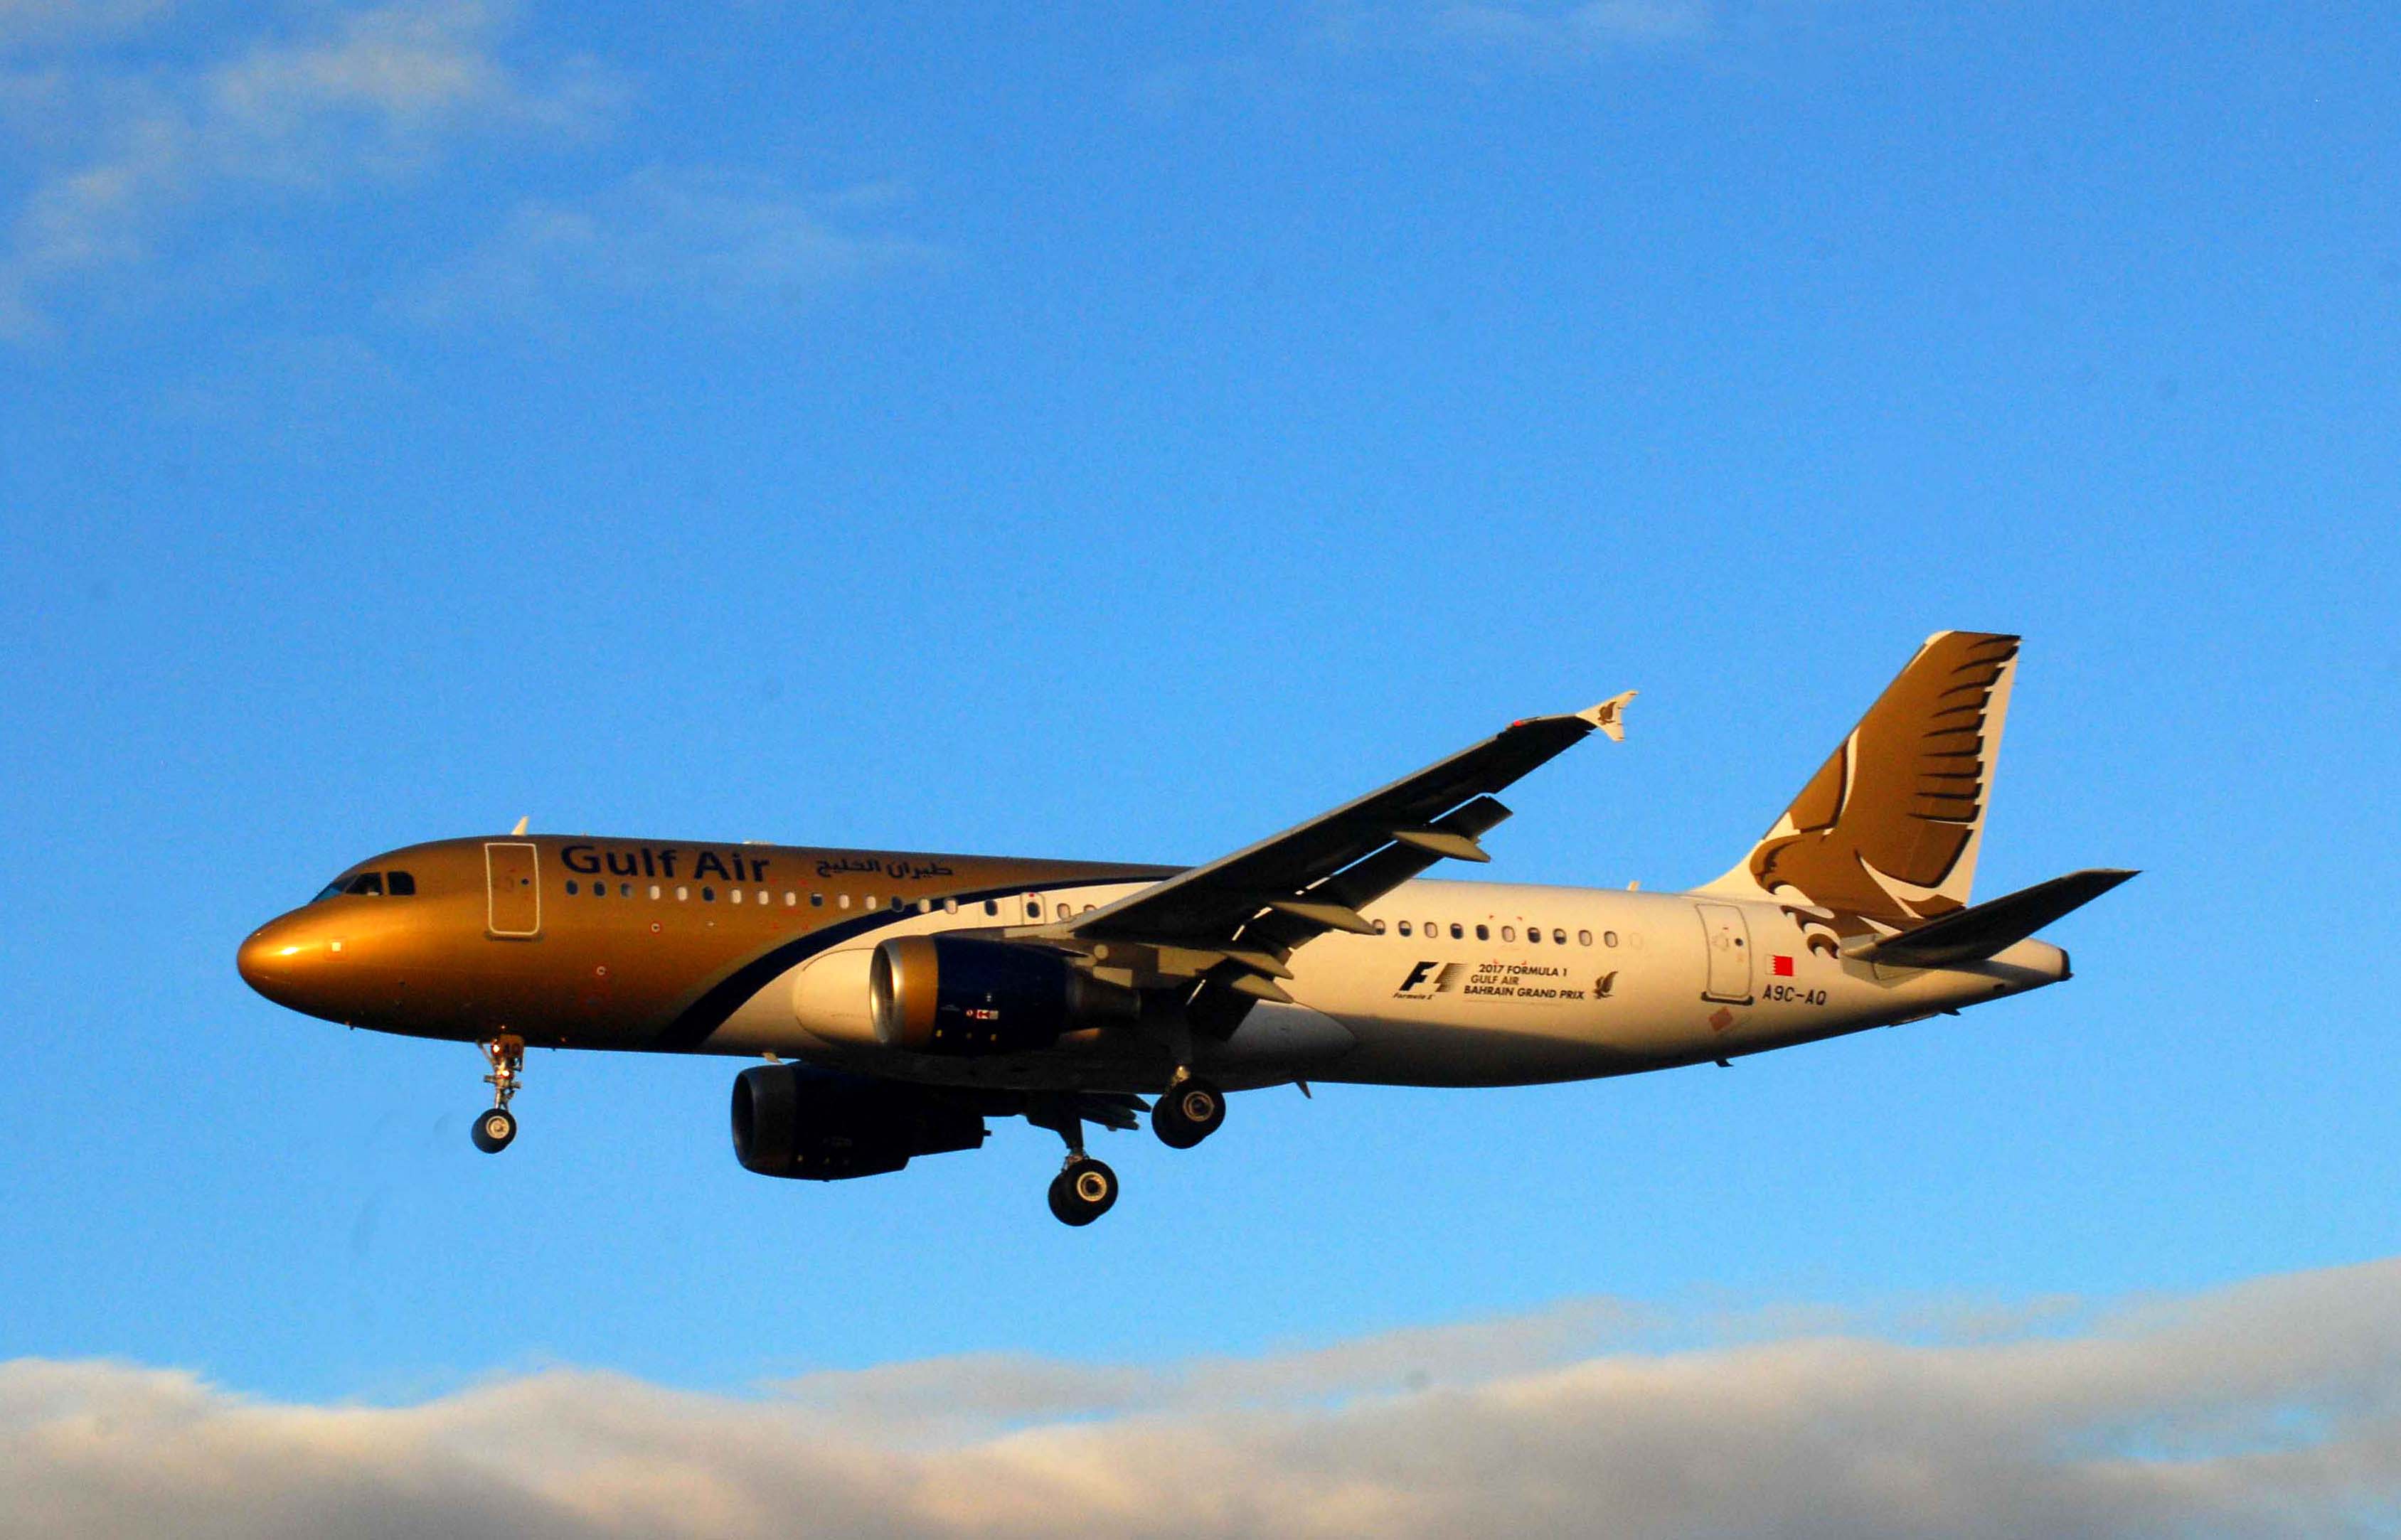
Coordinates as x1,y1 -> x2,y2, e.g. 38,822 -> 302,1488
238,631 -> 2134,1226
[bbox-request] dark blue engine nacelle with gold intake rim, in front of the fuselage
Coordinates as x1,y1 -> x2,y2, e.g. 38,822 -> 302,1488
867,936 -> 1143,1055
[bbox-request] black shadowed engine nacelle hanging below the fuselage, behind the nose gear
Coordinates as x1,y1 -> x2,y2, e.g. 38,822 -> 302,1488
735,1065 -> 984,1182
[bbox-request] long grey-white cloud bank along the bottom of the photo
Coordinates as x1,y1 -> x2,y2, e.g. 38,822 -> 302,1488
0,1262 -> 2401,1540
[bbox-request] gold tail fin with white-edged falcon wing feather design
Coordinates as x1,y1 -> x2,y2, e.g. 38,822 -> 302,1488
1703,631 -> 2017,936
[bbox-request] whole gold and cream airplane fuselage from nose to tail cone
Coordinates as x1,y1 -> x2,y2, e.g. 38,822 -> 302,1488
240,835 -> 2067,1091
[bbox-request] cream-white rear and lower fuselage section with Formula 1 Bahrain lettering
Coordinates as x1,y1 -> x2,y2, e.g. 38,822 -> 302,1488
703,880 -> 2067,1091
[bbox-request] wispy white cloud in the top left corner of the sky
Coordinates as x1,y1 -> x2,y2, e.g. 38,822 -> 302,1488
0,0 -> 607,336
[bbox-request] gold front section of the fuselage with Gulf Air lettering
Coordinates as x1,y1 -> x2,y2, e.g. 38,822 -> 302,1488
238,835 -> 1174,1053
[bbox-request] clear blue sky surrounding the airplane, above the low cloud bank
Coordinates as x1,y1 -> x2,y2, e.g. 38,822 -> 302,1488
0,0 -> 2401,1525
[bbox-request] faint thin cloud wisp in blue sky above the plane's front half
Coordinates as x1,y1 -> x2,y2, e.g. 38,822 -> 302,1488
406,168 -> 937,326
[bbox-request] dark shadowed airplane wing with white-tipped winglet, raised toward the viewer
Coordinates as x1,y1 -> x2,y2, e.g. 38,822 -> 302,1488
1032,691 -> 1635,1034
